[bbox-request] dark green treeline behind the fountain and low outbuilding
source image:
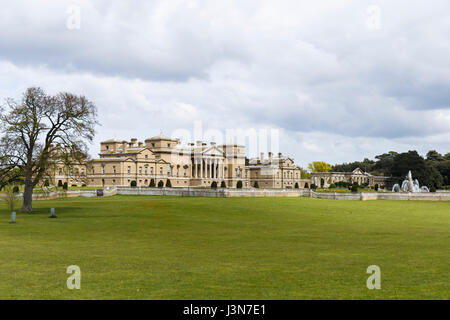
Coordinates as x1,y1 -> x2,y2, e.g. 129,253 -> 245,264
332,150 -> 450,189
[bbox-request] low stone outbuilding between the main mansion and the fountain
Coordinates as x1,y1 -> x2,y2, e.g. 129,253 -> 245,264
311,168 -> 388,188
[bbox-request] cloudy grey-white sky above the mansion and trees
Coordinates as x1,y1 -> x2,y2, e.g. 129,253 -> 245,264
0,0 -> 450,167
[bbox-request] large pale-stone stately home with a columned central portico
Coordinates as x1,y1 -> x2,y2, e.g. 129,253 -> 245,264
51,134 -> 309,188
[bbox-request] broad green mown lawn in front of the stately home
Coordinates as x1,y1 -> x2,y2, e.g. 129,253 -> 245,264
0,196 -> 450,299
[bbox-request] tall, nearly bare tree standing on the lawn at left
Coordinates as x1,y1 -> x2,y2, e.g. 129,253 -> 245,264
0,88 -> 98,212
